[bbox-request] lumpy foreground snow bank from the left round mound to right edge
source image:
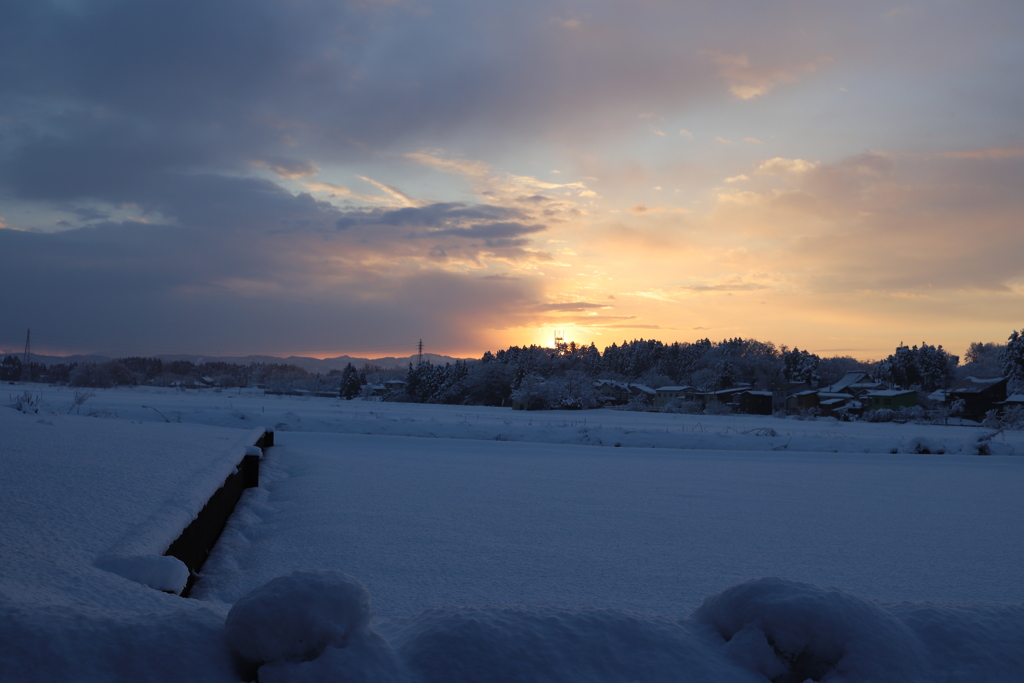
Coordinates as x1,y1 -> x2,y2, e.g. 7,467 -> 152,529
220,571 -> 1024,683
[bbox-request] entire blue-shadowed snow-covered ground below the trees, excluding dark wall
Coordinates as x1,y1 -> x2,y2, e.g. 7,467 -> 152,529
0,386 -> 1024,683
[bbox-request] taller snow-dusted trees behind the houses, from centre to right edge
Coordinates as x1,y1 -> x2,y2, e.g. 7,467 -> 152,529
390,331 -> 1024,408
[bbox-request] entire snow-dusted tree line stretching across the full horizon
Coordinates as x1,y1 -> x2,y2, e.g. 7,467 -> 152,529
8,330 -> 1024,408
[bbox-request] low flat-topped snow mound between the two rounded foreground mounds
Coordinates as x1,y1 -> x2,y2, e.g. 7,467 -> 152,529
391,606 -> 741,683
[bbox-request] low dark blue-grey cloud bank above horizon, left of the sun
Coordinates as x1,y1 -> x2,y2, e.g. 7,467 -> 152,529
0,223 -> 541,354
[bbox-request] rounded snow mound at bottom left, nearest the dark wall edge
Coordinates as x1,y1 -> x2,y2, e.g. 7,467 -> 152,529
224,570 -> 402,683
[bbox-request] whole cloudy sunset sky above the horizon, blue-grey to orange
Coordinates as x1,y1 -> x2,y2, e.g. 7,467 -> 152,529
0,0 -> 1024,359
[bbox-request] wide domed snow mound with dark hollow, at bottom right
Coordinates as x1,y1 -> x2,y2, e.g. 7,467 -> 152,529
691,579 -> 934,683
